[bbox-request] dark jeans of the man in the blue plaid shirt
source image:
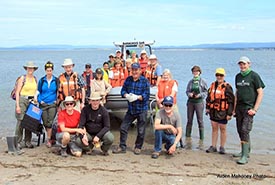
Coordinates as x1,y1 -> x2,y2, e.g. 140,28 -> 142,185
119,111 -> 147,150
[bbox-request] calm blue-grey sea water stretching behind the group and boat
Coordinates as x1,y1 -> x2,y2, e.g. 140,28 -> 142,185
0,48 -> 275,154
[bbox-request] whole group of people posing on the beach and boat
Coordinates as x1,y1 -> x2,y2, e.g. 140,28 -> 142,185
13,50 -> 265,164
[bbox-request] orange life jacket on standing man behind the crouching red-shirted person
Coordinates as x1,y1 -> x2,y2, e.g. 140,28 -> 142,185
58,72 -> 82,101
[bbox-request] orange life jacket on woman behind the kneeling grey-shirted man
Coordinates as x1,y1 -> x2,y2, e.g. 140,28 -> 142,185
158,80 -> 178,104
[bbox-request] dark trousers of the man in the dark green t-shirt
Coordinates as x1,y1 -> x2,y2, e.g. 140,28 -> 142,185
236,108 -> 253,142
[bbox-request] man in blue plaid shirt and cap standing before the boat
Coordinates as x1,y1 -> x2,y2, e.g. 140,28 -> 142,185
113,63 -> 150,155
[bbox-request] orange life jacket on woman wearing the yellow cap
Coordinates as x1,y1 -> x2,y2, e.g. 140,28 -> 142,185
207,82 -> 228,111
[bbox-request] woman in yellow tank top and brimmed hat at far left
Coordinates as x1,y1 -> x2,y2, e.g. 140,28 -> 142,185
15,61 -> 38,148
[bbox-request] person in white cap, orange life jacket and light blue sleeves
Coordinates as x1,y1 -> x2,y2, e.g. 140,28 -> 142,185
145,54 -> 162,86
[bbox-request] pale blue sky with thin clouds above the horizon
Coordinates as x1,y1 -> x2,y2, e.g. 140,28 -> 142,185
0,0 -> 275,47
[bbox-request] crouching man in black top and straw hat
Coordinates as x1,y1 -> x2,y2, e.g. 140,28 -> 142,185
76,92 -> 114,156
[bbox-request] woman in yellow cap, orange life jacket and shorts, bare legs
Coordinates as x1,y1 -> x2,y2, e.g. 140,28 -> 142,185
206,68 -> 235,154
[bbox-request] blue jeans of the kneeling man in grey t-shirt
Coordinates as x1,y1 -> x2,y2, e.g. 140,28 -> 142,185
154,130 -> 176,152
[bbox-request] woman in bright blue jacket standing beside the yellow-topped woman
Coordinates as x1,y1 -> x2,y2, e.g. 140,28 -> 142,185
37,61 -> 59,148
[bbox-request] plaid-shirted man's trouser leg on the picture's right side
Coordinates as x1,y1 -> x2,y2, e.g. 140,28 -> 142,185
135,112 -> 147,149
